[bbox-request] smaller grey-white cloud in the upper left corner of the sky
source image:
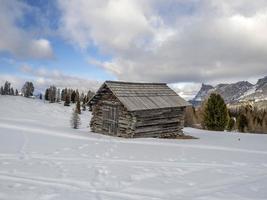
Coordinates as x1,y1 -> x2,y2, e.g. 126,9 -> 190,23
0,0 -> 53,59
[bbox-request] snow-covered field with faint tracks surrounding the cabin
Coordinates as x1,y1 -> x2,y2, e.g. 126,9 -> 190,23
0,96 -> 267,200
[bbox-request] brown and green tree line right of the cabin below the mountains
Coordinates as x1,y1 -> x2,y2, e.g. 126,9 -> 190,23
185,93 -> 267,133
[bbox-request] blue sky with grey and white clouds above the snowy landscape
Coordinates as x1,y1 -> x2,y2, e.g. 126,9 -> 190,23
0,0 -> 267,99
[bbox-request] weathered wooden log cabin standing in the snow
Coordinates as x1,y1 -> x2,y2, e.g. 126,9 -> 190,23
89,81 -> 189,138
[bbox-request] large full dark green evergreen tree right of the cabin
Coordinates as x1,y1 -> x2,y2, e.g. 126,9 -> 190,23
203,93 -> 228,131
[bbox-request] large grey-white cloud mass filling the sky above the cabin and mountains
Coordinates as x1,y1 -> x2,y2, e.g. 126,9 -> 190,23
59,0 -> 267,86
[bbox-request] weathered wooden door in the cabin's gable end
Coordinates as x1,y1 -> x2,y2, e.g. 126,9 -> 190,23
103,104 -> 118,135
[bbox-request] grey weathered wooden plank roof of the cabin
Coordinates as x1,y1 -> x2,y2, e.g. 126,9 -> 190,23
91,81 -> 189,111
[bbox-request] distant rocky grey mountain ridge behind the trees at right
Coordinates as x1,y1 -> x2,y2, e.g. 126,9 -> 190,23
190,76 -> 267,106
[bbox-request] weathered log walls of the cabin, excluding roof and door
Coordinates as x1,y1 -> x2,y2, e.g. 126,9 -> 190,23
90,84 -> 185,138
